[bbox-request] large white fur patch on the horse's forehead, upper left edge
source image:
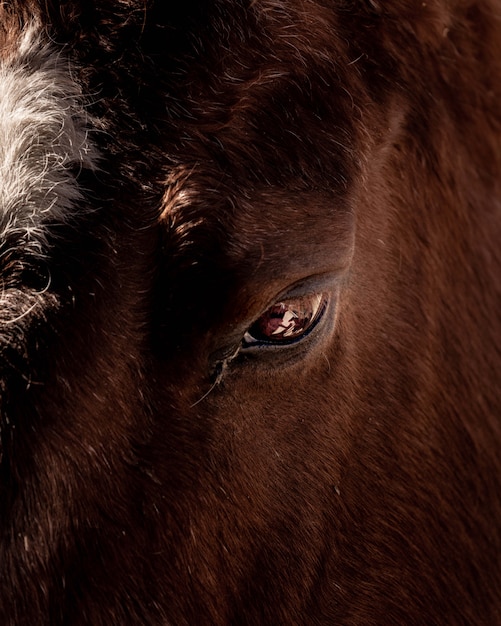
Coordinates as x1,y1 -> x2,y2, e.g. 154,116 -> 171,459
0,24 -> 97,255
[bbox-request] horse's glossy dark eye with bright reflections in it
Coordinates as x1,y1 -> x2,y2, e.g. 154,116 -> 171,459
243,293 -> 328,347
